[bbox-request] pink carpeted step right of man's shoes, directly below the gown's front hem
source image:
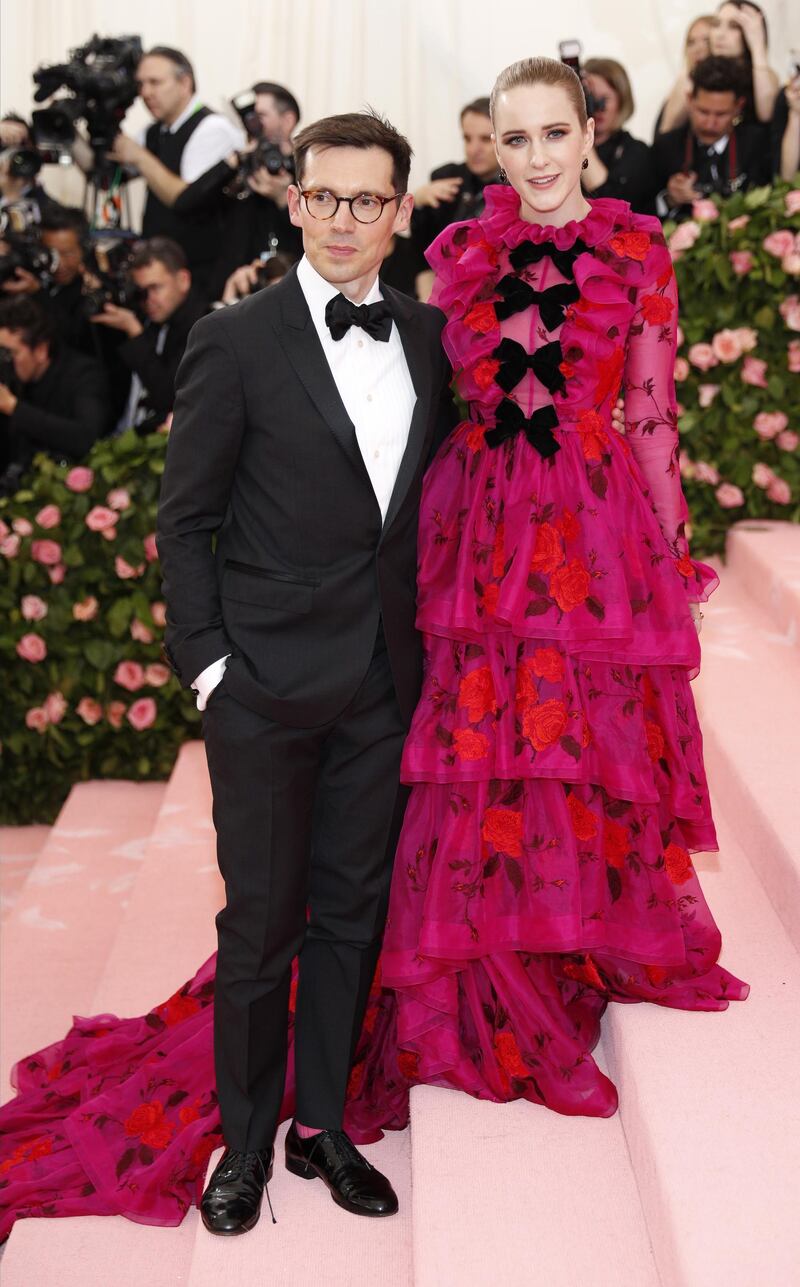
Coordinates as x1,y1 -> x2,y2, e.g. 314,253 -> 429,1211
412,1086 -> 663,1287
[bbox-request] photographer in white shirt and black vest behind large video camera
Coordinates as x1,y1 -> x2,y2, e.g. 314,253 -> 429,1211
108,45 -> 242,287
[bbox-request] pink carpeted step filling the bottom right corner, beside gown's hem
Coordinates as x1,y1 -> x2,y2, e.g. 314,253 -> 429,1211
607,803 -> 800,1287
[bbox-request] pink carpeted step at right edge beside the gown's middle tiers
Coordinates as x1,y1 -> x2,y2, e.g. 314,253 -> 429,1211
693,568 -> 800,950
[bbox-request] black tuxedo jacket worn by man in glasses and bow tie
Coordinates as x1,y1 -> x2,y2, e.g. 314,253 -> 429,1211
158,269 -> 454,727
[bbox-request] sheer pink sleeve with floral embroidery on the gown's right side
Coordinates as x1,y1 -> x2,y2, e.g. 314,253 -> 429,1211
624,257 -> 719,601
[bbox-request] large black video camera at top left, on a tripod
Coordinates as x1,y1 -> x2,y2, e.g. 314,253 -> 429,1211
31,35 -> 143,172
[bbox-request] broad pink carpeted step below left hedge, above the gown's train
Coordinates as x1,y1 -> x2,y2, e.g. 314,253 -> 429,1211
0,781 -> 165,1098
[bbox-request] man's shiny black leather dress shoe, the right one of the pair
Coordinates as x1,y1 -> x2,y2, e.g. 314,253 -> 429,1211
286,1122 -> 397,1215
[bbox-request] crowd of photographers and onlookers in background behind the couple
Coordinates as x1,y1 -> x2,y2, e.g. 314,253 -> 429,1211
0,0 -> 800,494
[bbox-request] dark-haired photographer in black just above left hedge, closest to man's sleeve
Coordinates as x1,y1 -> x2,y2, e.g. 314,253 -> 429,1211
91,237 -> 208,431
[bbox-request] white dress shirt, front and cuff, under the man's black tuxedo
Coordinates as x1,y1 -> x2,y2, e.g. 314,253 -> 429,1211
193,255 -> 417,710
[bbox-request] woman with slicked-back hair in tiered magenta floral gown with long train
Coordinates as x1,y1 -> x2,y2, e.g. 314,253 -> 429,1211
0,59 -> 749,1237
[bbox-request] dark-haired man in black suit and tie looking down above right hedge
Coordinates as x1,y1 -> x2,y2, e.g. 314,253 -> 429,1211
652,55 -> 772,220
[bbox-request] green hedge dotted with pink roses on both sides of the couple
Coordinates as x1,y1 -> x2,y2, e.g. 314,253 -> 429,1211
0,184 -> 800,822
